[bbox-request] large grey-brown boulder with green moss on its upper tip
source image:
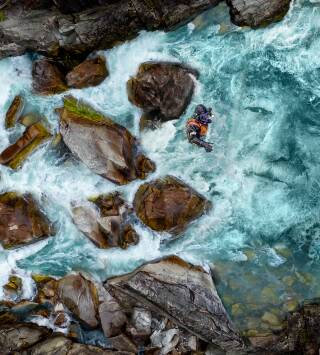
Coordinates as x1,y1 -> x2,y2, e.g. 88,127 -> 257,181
58,96 -> 155,185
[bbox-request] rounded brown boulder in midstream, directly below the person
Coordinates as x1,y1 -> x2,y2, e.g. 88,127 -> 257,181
133,176 -> 211,234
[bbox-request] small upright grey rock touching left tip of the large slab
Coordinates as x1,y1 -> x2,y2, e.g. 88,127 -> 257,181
99,294 -> 128,338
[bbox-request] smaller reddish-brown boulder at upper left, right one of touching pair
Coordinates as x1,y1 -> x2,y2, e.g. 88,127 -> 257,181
66,56 -> 108,89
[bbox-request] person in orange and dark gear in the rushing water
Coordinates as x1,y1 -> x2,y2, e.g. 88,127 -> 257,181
187,105 -> 213,152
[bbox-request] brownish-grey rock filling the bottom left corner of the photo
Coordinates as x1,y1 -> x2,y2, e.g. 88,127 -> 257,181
0,323 -> 51,354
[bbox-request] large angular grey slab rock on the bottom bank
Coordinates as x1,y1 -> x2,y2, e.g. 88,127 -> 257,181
106,256 -> 244,351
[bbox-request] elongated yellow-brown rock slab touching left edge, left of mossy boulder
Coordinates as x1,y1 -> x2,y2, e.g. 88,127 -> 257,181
0,123 -> 51,169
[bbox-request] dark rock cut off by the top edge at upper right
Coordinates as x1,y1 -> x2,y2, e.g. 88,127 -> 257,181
227,0 -> 291,28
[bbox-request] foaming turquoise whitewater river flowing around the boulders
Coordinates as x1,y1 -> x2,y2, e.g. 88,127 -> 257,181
0,0 -> 320,330
